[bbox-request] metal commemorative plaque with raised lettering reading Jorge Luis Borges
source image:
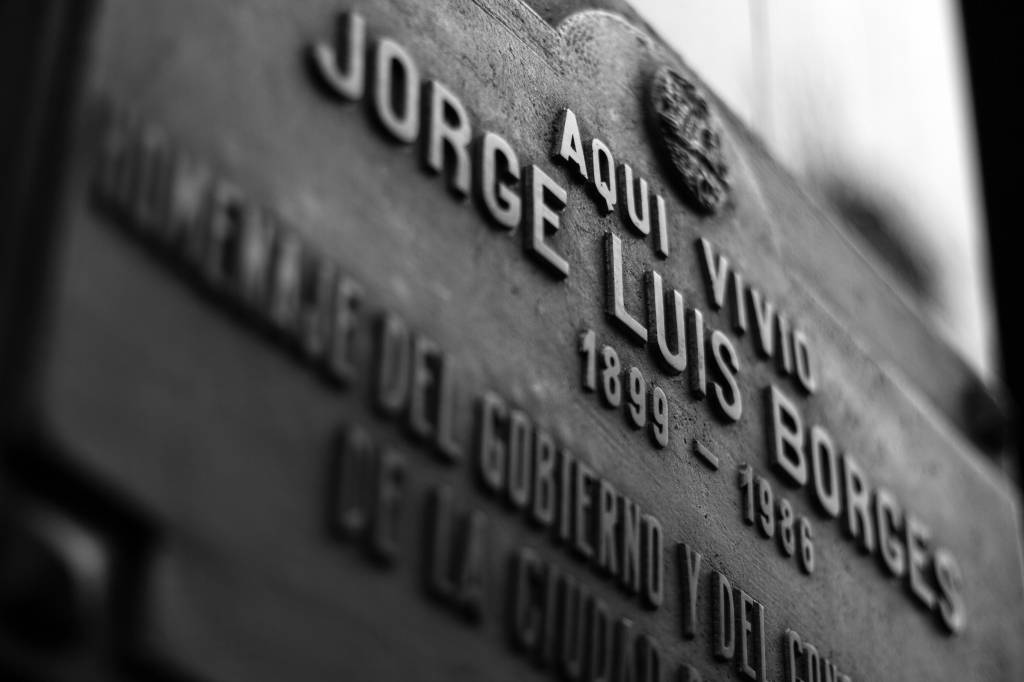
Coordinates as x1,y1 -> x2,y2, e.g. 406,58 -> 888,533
2,0 -> 1024,682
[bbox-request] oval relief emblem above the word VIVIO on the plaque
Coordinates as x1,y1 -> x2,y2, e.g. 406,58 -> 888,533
650,67 -> 729,213
